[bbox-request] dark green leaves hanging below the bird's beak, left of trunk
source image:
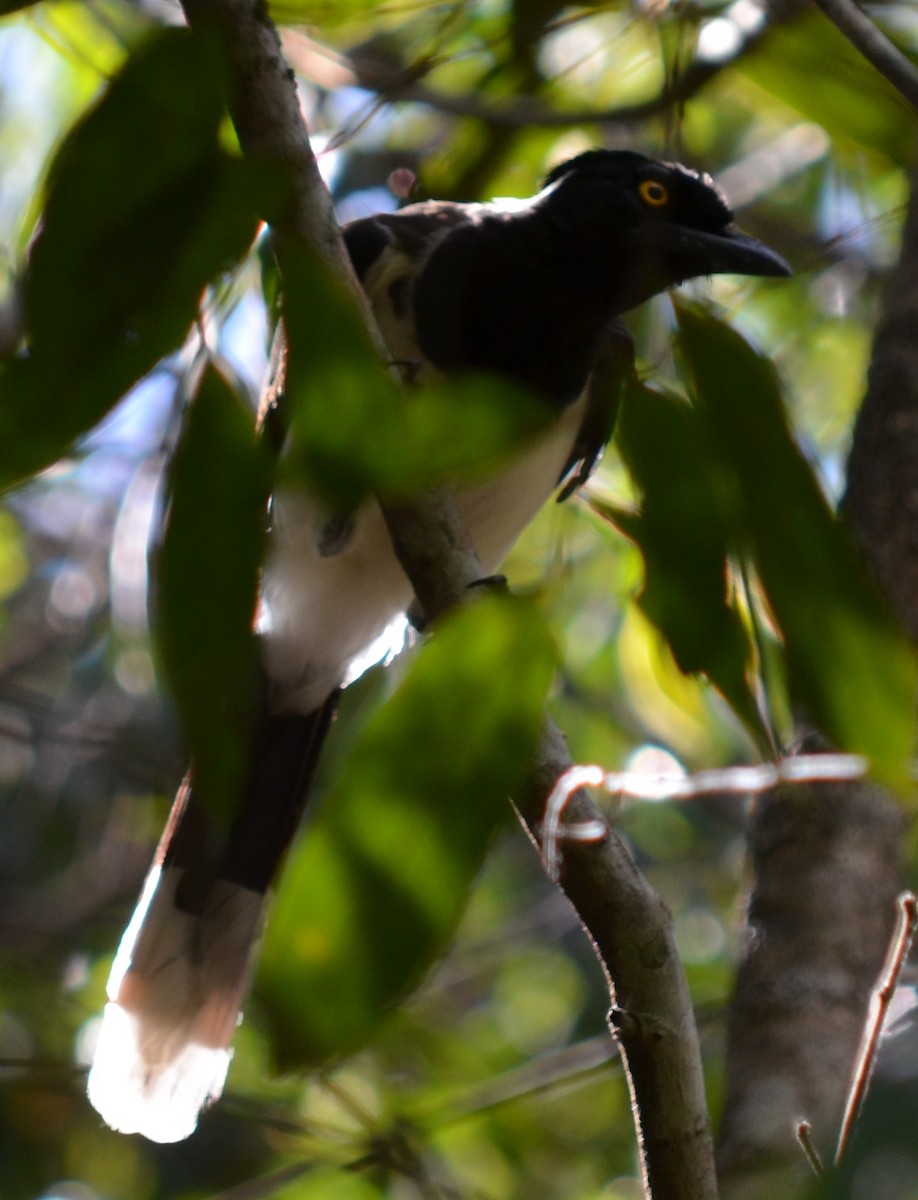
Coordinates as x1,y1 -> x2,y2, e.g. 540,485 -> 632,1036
595,302 -> 918,787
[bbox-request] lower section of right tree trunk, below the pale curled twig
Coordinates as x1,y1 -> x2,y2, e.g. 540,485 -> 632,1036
719,784 -> 902,1200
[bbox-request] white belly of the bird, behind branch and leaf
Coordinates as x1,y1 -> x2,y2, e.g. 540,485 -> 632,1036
263,398 -> 586,712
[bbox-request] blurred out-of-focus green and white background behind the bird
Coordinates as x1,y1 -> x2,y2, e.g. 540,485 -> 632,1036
0,0 -> 918,1200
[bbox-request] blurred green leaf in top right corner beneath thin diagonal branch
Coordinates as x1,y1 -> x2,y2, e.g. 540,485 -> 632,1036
737,12 -> 914,167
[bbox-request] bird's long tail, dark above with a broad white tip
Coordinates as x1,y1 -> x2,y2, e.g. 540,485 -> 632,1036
89,696 -> 337,1141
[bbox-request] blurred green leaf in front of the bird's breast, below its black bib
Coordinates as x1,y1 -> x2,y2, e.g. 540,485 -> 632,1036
284,247 -> 550,506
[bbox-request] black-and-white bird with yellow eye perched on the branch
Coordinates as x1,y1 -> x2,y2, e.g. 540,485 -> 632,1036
89,150 -> 790,1141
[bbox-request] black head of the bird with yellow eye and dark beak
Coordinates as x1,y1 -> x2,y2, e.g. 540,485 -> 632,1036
541,150 -> 792,312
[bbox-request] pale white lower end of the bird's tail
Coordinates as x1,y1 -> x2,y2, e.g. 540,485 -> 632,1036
88,865 -> 264,1142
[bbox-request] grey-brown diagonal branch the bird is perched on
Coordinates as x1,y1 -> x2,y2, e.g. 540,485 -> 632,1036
184,0 -> 716,1200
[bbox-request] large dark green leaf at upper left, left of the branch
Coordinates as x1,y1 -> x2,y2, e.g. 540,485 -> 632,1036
0,30 -> 277,486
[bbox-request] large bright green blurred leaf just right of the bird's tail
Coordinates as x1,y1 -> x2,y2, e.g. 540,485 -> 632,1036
260,598 -> 554,1066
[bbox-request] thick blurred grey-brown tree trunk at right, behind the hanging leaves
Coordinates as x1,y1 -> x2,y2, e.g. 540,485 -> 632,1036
719,154 -> 918,1200
